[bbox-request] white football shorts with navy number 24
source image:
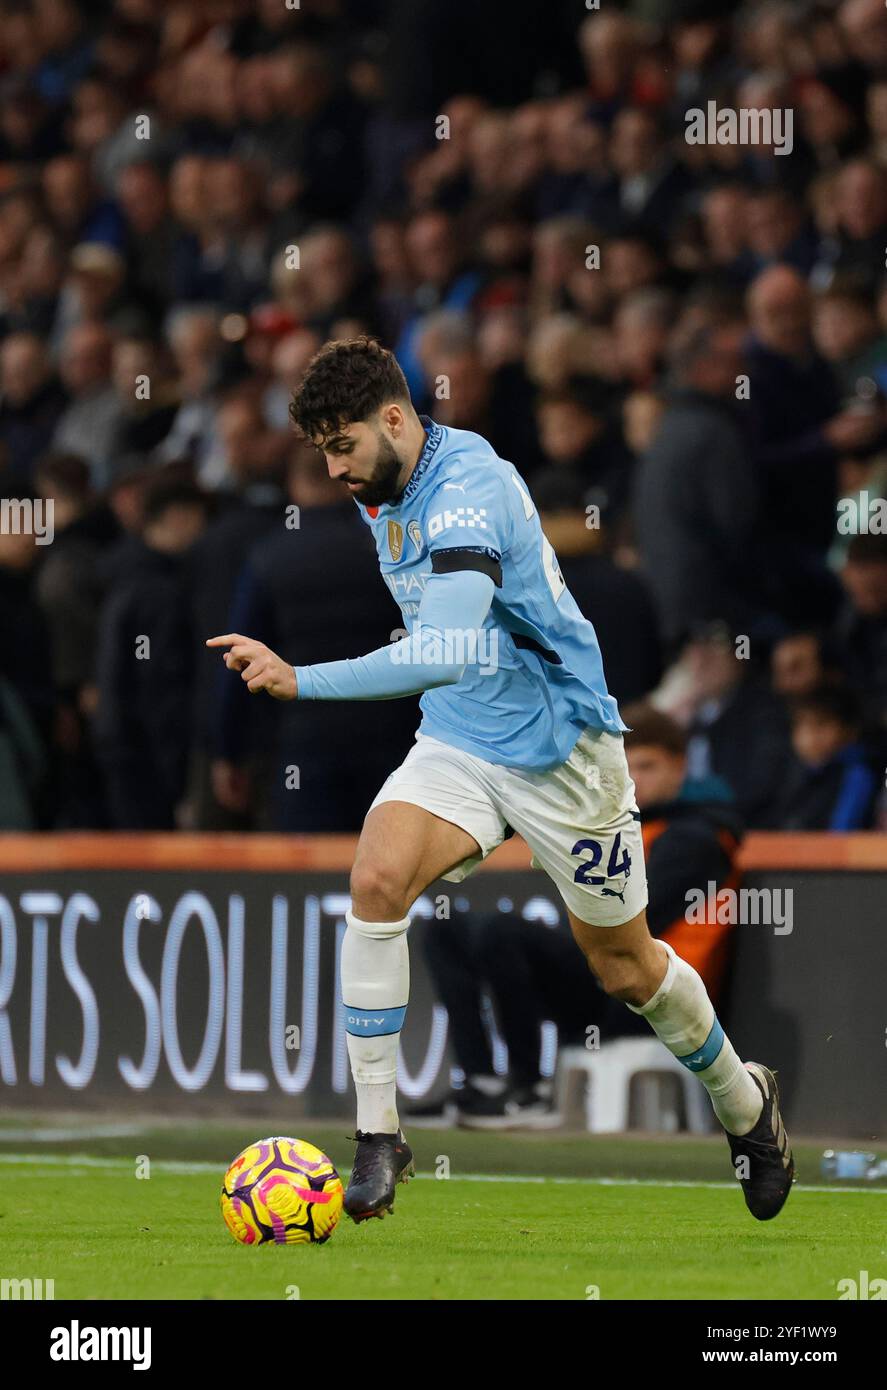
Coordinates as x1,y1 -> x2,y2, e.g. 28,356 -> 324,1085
370,730 -> 646,927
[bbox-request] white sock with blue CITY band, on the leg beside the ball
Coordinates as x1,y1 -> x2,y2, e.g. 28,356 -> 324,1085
341,912 -> 410,1134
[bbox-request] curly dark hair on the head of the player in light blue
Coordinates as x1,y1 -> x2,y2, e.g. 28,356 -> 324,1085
289,335 -> 410,445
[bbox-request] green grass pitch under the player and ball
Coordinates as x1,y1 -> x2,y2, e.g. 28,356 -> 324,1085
0,1118 -> 887,1300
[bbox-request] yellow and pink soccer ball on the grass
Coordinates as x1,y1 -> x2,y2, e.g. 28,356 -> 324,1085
220,1138 -> 345,1245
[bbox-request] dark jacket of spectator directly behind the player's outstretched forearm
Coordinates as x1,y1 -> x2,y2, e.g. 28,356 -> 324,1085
211,500 -> 418,833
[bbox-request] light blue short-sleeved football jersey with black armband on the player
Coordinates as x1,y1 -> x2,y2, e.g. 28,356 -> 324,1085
357,416 -> 627,771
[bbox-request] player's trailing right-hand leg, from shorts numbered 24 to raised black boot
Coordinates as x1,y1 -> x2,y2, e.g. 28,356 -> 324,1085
501,734 -> 794,1220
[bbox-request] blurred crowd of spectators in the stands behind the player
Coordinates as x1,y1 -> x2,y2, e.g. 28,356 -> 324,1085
0,0 -> 887,831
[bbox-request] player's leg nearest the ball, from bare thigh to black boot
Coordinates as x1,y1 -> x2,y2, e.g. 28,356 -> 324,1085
341,801 -> 481,1222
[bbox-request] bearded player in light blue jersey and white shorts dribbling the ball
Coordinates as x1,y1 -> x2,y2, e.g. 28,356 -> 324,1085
207,338 -> 794,1222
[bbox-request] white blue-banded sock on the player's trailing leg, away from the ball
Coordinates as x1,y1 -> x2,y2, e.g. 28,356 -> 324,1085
628,941 -> 763,1134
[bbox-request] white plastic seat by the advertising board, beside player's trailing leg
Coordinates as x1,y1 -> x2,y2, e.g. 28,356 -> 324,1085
556,1037 -> 713,1134
